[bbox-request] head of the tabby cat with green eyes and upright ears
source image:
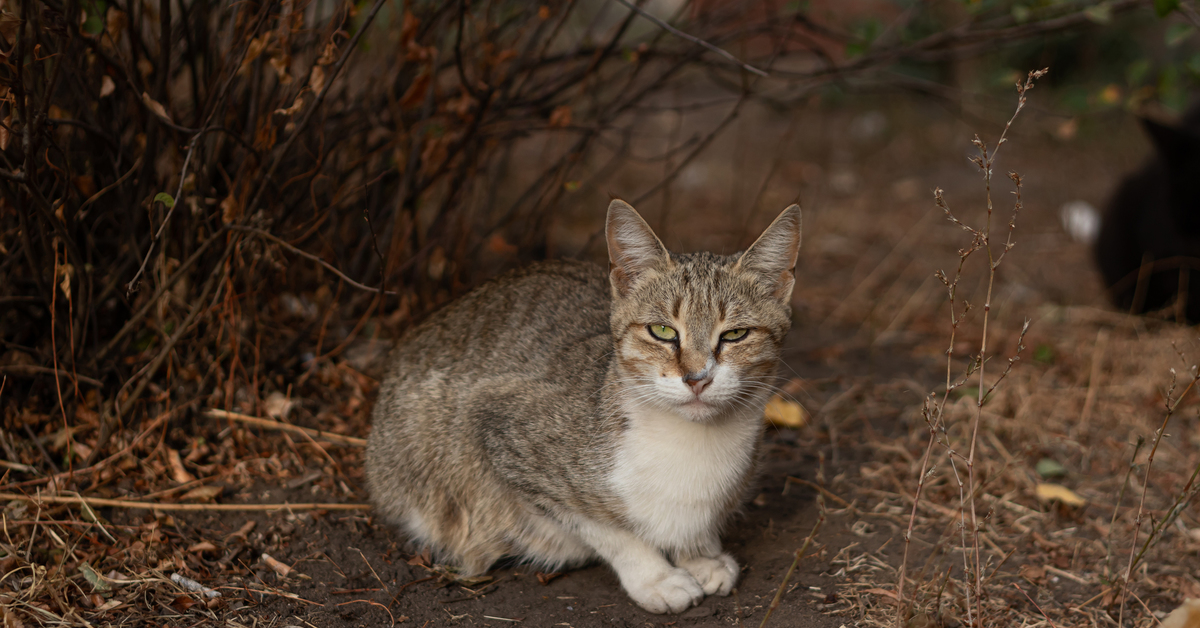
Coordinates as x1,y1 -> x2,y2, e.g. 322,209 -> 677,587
606,201 -> 800,423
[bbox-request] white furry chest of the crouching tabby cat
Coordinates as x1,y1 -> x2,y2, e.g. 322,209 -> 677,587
612,409 -> 760,549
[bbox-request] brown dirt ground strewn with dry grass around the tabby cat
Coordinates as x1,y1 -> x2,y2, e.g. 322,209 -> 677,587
9,91 -> 1200,628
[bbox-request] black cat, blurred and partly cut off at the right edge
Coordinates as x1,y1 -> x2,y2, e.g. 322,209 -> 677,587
1094,106 -> 1200,323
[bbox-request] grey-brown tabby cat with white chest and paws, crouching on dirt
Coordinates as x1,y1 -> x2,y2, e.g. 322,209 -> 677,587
366,201 -> 800,614
